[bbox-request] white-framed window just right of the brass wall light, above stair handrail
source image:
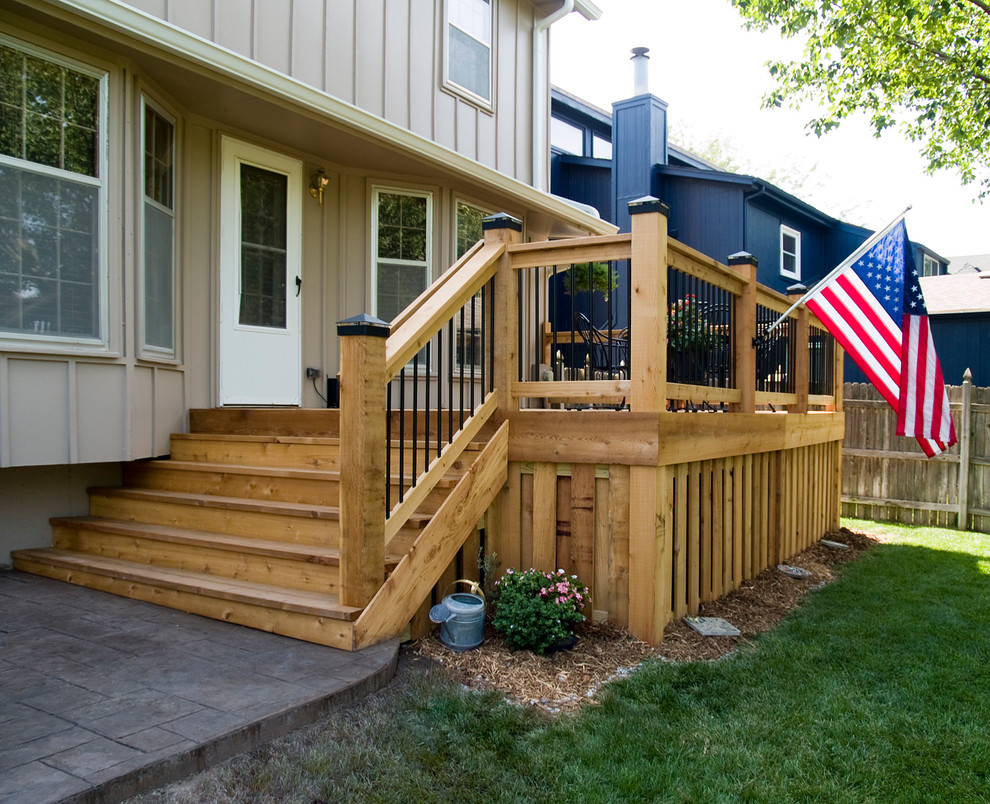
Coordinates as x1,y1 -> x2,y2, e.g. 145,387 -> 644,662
372,187 -> 433,321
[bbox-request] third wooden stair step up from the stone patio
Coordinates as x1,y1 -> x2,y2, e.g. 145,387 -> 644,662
89,488 -> 429,547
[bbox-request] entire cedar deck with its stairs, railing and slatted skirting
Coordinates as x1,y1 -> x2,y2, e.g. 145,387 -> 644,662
14,205 -> 844,649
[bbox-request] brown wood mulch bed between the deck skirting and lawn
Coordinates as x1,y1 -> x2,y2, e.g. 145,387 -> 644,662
413,528 -> 880,714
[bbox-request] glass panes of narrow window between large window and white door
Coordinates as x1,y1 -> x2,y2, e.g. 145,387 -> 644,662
142,101 -> 175,355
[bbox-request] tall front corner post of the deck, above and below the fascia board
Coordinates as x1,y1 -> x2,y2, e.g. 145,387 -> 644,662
629,197 -> 673,645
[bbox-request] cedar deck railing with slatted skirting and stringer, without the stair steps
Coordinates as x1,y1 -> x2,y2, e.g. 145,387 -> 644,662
341,200 -> 843,644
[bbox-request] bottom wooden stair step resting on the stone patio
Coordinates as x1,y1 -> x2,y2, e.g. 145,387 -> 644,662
11,547 -> 360,650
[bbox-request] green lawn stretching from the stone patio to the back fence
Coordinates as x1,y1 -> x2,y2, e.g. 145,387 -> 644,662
141,520 -> 990,804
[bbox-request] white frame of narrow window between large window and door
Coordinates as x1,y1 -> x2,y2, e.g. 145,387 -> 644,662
138,93 -> 179,362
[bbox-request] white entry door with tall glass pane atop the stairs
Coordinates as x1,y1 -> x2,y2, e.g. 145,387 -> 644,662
220,137 -> 303,405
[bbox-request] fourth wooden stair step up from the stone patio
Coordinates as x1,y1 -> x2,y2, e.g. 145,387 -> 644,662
124,460 -> 459,513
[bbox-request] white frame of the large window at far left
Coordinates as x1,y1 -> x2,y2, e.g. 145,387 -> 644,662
0,34 -> 111,353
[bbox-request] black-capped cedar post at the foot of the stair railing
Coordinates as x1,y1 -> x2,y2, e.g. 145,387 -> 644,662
337,315 -> 389,608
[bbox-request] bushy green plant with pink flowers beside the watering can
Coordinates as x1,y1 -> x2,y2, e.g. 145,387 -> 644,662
492,569 -> 591,654
